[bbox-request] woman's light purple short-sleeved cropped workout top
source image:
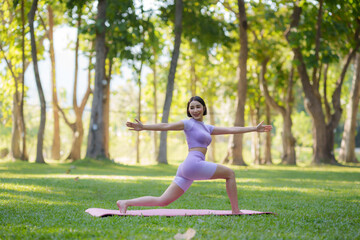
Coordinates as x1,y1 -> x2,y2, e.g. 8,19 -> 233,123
182,118 -> 214,149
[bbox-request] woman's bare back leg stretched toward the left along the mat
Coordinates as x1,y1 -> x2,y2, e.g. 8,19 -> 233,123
116,182 -> 184,213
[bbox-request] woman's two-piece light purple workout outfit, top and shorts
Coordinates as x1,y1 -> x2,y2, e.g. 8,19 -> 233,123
174,118 -> 217,192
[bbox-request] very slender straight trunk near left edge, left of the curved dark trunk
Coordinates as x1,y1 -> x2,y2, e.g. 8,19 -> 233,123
19,0 -> 29,161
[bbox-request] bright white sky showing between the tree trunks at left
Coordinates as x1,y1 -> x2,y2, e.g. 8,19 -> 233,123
25,26 -> 125,106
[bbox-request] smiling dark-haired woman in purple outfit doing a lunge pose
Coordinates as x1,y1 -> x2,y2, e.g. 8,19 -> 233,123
116,96 -> 272,214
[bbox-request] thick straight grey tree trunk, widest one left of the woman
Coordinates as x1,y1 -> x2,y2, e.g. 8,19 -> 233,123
86,0 -> 109,158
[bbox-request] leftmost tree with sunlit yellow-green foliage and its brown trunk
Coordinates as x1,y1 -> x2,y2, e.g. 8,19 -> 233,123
0,1 -> 31,161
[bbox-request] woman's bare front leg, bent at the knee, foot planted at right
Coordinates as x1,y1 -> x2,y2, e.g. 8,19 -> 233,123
211,164 -> 241,213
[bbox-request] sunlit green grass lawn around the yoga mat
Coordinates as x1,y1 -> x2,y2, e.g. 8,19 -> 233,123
0,160 -> 360,239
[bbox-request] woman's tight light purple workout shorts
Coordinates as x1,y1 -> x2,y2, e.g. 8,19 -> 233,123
174,151 -> 217,192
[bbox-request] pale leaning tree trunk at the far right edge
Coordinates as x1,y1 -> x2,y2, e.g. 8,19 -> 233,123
339,53 -> 360,163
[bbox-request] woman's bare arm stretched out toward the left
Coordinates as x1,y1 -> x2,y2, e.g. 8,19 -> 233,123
126,119 -> 184,131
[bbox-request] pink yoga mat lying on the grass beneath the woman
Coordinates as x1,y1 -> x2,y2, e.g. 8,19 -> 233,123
85,208 -> 274,217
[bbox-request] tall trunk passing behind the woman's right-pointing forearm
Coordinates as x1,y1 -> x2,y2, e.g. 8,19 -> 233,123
228,0 -> 248,166
